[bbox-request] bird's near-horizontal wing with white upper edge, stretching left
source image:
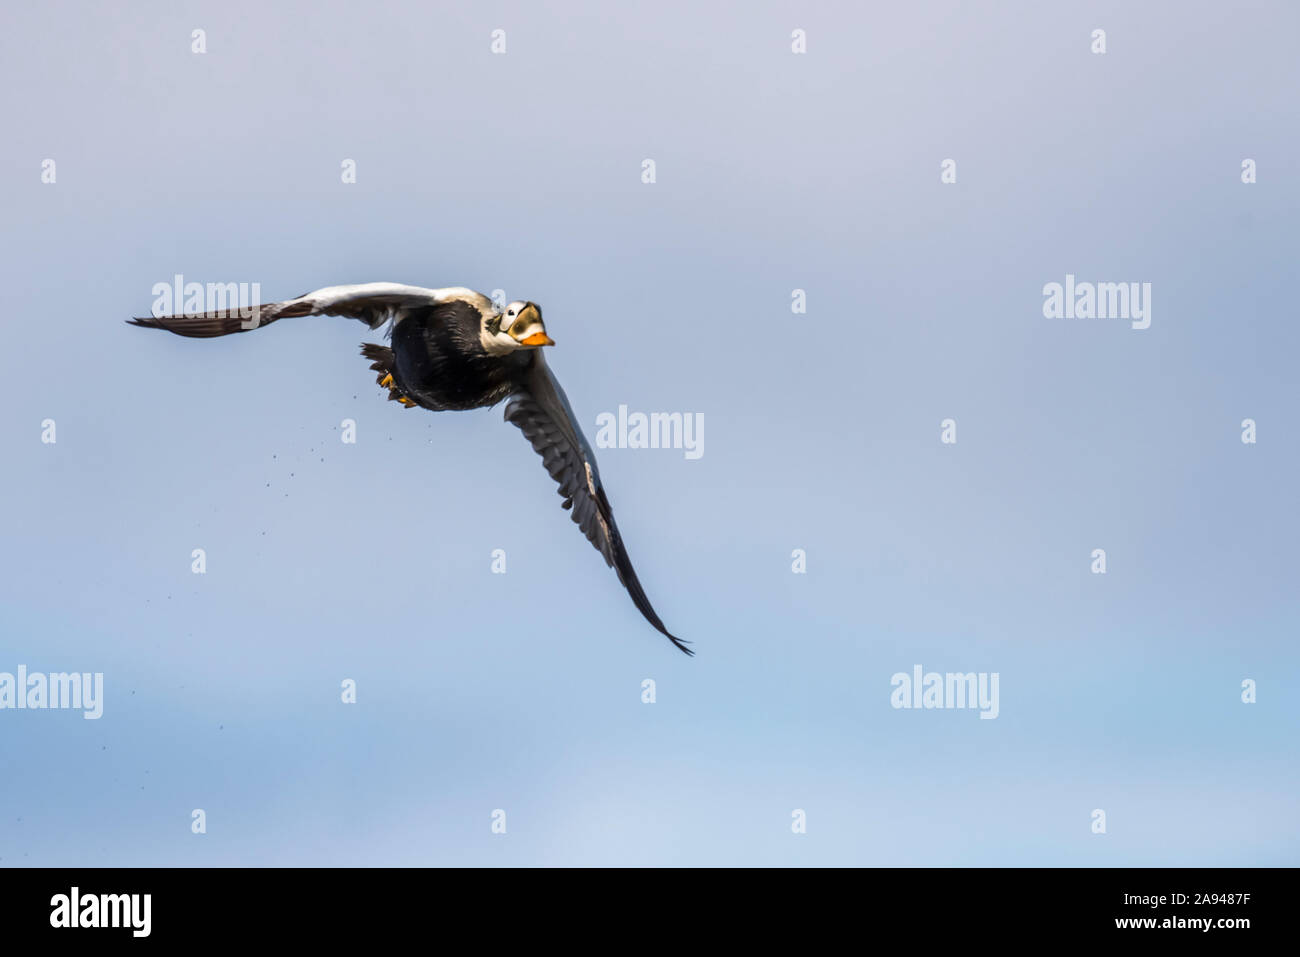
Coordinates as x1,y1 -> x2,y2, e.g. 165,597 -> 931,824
127,282 -> 491,339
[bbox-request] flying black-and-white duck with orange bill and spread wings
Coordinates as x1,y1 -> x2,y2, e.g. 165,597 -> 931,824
129,282 -> 694,654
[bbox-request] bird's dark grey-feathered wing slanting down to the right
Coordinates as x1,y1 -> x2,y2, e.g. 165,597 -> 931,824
506,350 -> 694,654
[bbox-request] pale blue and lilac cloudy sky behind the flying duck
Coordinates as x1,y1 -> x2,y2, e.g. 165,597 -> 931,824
0,3 -> 1300,865
